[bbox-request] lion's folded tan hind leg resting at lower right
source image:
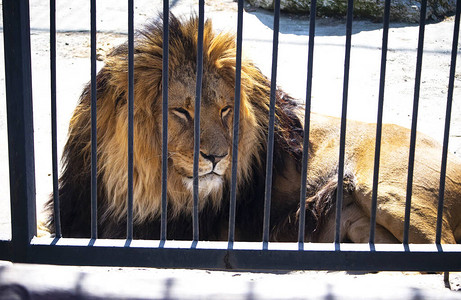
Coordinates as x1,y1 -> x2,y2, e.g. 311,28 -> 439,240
307,172 -> 456,244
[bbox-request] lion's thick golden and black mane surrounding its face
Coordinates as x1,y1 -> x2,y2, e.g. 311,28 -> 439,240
48,16 -> 303,240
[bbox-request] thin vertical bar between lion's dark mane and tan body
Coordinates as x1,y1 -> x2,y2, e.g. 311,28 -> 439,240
298,0 -> 317,250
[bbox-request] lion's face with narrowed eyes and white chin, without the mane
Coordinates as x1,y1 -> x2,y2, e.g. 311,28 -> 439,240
168,66 -> 234,197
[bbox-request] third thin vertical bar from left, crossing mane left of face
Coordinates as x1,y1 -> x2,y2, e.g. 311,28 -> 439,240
126,0 -> 134,240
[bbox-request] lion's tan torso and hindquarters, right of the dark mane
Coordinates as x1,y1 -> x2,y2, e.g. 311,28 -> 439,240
300,114 -> 461,243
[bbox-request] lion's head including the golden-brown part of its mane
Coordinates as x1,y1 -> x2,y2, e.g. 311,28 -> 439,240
91,19 -> 269,222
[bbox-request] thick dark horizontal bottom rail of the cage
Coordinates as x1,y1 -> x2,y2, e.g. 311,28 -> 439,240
27,240 -> 461,272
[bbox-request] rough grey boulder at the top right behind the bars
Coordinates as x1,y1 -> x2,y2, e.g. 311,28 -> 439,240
248,0 -> 456,23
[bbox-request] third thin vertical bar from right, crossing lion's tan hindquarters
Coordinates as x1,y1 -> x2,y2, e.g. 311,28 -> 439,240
369,0 -> 391,244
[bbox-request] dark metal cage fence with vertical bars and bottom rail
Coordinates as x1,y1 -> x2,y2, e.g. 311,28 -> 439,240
0,0 -> 461,271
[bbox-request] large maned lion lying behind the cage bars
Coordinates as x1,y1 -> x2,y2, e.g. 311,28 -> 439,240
43,15 -> 461,243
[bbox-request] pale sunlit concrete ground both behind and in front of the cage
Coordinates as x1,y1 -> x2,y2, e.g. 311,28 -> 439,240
0,0 -> 461,299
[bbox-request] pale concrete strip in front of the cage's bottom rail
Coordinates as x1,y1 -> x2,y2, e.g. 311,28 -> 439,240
0,262 -> 461,300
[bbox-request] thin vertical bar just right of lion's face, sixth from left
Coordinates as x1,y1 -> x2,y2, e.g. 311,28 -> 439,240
228,0 -> 243,243
